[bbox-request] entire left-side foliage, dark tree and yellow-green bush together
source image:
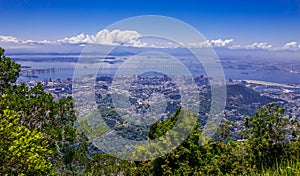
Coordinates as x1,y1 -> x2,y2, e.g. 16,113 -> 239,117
0,48 -> 86,175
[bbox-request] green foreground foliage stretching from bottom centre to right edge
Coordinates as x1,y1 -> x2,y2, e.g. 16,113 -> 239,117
133,104 -> 300,175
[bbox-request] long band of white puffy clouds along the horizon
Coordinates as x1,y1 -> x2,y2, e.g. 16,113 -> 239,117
0,29 -> 300,50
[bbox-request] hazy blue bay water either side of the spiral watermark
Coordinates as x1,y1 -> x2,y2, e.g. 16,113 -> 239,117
11,55 -> 300,85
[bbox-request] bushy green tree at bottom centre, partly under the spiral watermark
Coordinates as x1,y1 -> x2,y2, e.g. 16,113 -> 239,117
133,108 -> 201,175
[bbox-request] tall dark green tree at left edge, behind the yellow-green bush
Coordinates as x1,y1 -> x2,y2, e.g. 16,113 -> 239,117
0,48 -> 86,175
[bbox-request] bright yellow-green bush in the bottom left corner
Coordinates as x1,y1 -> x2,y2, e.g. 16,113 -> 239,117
0,108 -> 54,175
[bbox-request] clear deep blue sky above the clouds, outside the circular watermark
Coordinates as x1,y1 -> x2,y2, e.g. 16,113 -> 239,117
0,0 -> 300,47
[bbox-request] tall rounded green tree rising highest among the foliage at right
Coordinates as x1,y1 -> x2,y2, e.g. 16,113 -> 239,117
245,103 -> 292,169
